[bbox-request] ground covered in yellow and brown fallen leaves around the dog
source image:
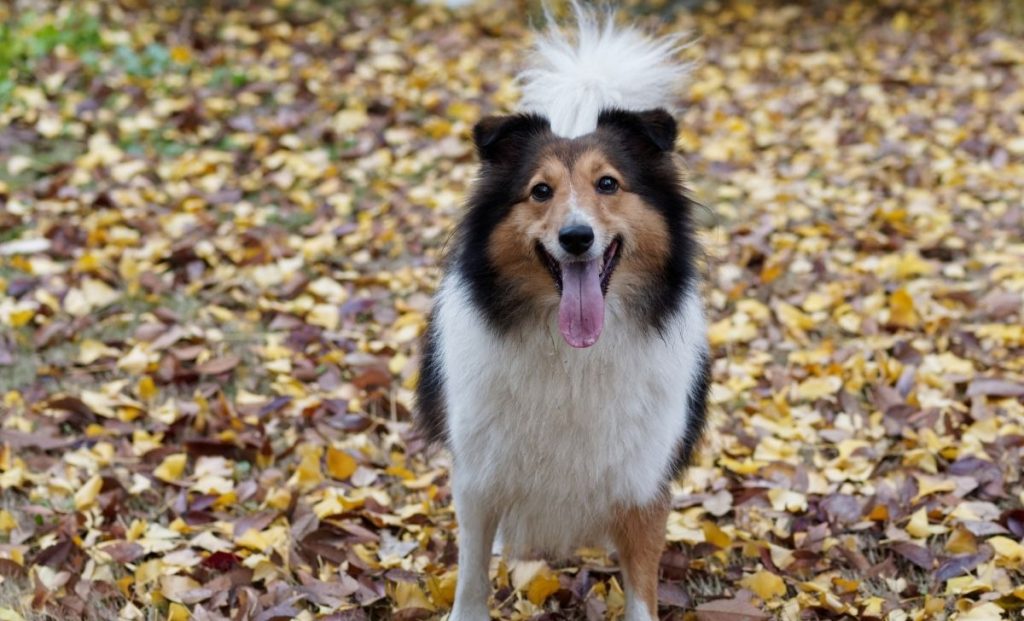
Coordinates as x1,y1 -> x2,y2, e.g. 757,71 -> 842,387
0,0 -> 1024,621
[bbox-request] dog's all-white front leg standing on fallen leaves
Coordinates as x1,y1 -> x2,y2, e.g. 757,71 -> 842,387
449,487 -> 498,621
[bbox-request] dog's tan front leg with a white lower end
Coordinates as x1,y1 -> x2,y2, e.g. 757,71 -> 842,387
612,494 -> 670,621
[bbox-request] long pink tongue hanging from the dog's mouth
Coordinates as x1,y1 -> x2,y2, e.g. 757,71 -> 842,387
558,257 -> 604,347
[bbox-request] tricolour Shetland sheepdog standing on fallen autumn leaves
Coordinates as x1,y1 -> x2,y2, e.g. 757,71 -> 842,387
417,4 -> 710,621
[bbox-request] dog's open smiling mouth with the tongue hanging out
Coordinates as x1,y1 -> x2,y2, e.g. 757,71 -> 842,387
537,237 -> 623,347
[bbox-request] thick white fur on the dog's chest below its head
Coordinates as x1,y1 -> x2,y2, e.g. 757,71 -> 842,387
436,277 -> 707,554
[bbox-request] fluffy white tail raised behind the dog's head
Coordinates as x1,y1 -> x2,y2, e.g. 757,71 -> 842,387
518,0 -> 689,138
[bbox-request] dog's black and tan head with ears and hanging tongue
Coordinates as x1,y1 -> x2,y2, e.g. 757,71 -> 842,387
463,110 -> 688,347
